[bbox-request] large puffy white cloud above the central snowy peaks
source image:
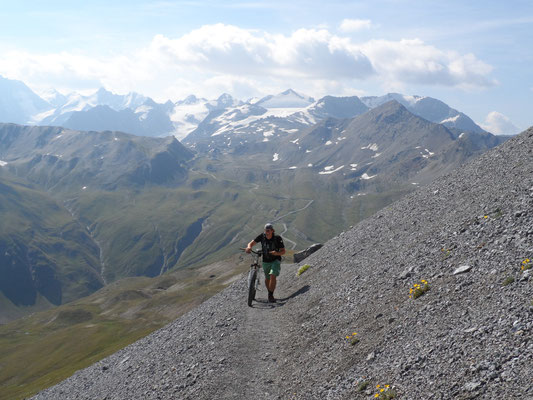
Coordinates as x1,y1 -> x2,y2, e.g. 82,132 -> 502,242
150,24 -> 373,79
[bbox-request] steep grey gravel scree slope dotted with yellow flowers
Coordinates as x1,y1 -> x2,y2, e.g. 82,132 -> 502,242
36,128 -> 533,400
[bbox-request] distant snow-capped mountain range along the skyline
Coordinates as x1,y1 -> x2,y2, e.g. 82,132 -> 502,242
0,78 -> 490,140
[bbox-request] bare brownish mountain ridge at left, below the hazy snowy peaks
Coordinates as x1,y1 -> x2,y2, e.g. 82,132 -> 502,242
0,124 -> 193,190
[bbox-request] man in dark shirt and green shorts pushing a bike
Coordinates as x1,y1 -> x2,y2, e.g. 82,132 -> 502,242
246,223 -> 285,303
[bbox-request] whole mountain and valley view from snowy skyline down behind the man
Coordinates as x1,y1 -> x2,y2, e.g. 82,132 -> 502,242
0,79 -> 506,322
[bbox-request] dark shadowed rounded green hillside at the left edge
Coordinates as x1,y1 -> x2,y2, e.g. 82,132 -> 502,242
0,176 -> 102,321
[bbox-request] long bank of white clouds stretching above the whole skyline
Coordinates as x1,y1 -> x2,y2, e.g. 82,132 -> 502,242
0,20 -> 496,100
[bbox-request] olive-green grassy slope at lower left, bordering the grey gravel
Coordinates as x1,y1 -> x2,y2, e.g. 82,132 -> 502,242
0,254 -> 262,400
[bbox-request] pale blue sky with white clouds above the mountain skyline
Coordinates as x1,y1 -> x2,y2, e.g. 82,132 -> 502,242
0,0 -> 533,133
